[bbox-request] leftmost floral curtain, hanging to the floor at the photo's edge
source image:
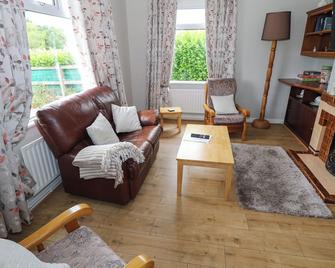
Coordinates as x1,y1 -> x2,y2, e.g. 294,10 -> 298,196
0,0 -> 34,237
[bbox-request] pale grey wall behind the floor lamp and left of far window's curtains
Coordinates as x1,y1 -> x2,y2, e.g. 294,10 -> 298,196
126,0 -> 333,122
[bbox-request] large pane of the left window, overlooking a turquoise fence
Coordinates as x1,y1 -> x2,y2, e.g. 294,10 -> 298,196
26,12 -> 82,112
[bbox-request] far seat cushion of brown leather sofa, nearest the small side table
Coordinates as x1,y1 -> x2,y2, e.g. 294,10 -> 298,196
119,126 -> 162,145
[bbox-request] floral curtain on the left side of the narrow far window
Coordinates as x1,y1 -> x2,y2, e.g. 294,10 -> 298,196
146,0 -> 177,109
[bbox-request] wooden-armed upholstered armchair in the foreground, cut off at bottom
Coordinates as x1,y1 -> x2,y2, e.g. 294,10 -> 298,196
20,204 -> 154,268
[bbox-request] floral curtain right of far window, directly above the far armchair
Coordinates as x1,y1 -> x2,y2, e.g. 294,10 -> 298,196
206,0 -> 237,78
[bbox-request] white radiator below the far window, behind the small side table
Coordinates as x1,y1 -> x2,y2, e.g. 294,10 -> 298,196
169,89 -> 205,114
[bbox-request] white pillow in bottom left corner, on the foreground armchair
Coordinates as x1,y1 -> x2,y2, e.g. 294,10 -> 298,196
0,239 -> 70,268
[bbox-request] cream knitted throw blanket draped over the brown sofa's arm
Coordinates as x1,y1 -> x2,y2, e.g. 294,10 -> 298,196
72,142 -> 145,188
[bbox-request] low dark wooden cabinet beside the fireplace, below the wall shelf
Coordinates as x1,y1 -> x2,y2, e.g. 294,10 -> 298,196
279,79 -> 326,146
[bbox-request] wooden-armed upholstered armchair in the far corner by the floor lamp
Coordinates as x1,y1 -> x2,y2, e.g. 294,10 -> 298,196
204,79 -> 250,140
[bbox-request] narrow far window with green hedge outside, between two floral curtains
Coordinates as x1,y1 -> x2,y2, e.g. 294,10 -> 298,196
172,9 -> 207,81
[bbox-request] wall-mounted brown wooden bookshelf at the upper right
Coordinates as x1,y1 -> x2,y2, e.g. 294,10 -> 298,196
301,4 -> 335,58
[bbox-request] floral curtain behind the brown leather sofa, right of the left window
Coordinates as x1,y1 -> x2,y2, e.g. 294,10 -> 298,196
68,0 -> 127,105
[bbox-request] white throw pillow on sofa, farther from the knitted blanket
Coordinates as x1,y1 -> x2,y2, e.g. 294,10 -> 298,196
112,104 -> 142,133
